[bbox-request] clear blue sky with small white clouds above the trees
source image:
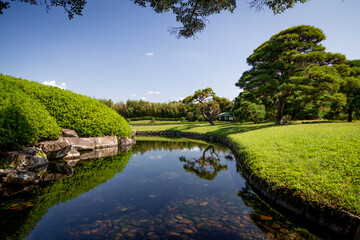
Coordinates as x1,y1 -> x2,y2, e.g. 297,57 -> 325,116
0,0 -> 360,102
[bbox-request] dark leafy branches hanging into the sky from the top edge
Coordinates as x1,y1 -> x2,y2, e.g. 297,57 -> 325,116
0,0 -> 310,38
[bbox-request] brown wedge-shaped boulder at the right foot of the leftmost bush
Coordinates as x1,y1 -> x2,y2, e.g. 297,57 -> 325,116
38,141 -> 72,160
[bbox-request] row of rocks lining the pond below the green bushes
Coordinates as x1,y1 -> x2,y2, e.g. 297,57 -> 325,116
0,129 -> 136,195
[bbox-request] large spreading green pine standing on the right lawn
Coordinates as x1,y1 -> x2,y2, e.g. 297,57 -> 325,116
236,25 -> 345,124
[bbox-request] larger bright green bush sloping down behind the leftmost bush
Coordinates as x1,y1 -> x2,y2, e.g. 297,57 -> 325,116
1,75 -> 131,137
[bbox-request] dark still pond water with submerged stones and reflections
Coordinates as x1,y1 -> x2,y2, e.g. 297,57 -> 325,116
0,138 -> 320,240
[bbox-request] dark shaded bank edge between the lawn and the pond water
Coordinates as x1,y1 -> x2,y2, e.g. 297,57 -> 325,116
136,132 -> 360,240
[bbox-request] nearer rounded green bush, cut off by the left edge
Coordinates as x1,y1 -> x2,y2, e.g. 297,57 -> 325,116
0,75 -> 61,150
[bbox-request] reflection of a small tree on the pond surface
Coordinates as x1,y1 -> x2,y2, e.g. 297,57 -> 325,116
179,145 -> 228,180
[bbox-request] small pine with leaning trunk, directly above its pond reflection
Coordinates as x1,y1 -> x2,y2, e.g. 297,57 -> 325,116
183,88 -> 220,125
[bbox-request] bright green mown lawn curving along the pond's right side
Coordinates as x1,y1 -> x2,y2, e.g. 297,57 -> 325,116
133,121 -> 360,215
